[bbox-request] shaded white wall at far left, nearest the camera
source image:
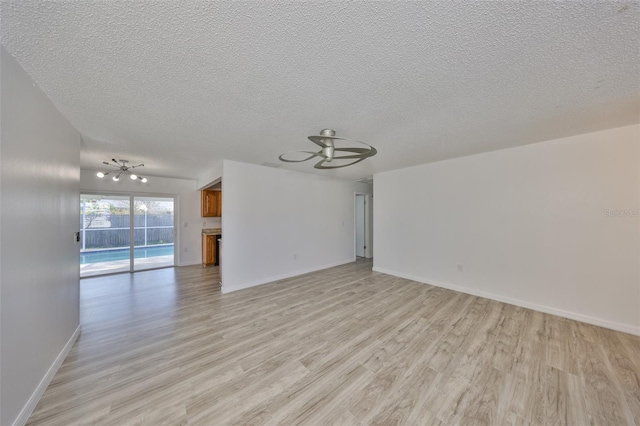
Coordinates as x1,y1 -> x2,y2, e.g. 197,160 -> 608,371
0,47 -> 80,425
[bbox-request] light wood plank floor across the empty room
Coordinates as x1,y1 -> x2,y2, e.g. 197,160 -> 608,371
29,261 -> 640,426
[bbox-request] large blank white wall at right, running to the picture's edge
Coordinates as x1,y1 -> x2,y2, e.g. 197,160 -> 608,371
374,125 -> 640,334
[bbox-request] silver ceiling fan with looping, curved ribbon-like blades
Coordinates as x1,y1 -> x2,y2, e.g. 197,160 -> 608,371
279,129 -> 378,169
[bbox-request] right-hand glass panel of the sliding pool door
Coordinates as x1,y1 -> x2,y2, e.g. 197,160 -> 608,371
133,196 -> 175,271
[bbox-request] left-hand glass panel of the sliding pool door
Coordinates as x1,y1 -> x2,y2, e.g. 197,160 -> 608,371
80,194 -> 131,277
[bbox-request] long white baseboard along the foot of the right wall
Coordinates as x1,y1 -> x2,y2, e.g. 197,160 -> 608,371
373,267 -> 640,336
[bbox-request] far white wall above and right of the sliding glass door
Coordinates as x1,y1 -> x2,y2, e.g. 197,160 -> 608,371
80,170 -> 221,266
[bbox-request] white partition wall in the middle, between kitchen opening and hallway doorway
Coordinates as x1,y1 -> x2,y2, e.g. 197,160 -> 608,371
222,160 -> 370,292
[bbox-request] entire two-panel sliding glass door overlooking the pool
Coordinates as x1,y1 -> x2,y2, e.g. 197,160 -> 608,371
80,194 -> 175,277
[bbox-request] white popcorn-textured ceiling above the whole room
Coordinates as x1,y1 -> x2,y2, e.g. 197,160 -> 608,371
1,0 -> 640,179
